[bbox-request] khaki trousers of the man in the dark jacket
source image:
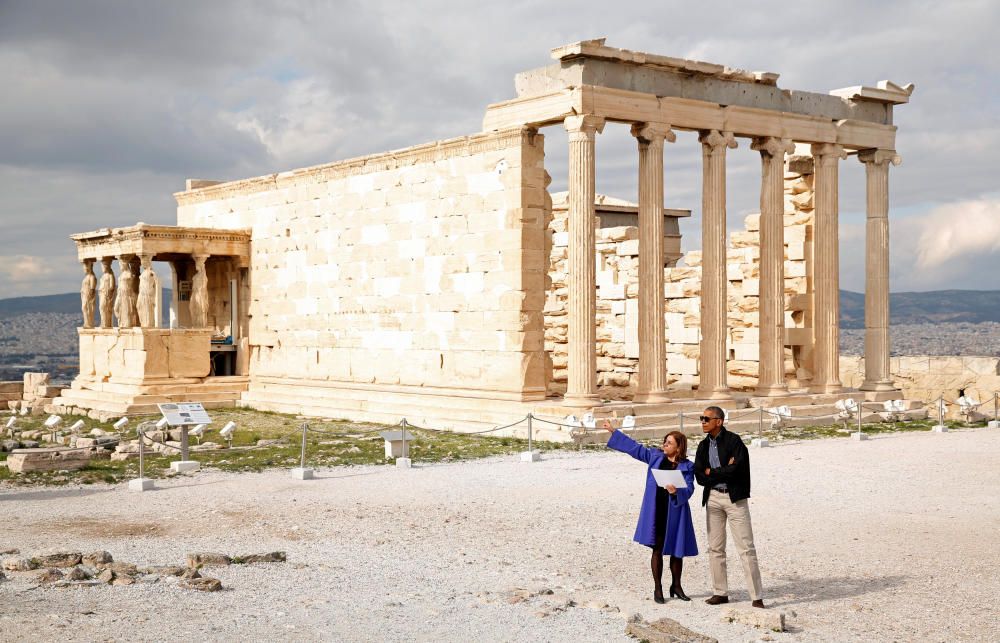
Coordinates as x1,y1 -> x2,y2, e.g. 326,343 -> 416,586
705,489 -> 764,601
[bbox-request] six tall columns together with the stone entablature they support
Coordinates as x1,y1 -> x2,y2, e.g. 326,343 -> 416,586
483,39 -> 913,407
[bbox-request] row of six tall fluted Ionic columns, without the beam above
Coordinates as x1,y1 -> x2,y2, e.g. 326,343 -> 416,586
560,115 -> 899,407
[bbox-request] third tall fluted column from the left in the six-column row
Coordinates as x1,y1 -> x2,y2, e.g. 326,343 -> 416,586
698,130 -> 736,399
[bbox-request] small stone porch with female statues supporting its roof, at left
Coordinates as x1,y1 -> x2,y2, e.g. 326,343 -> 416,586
55,223 -> 250,414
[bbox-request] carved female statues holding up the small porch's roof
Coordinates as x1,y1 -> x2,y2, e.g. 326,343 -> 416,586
80,254 -> 209,328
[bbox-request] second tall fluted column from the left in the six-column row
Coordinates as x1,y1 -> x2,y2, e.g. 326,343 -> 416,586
632,123 -> 677,402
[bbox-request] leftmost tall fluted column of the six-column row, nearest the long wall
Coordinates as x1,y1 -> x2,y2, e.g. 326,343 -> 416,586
564,116 -> 604,406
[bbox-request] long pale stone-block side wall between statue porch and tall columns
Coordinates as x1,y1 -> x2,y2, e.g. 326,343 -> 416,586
177,129 -> 546,401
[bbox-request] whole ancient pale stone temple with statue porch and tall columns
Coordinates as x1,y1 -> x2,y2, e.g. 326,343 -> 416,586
57,40 -> 913,429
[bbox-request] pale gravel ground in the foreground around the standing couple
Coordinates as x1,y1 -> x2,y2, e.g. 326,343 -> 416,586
0,429 -> 1000,641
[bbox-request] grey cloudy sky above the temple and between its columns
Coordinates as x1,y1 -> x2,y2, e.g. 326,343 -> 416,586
0,0 -> 1000,298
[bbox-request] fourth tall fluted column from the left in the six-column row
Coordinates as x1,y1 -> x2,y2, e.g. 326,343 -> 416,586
751,136 -> 795,396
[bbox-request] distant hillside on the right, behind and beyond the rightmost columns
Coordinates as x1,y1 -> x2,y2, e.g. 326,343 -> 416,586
840,290 -> 1000,328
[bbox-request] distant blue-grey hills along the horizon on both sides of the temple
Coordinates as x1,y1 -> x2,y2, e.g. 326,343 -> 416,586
0,288 -> 1000,328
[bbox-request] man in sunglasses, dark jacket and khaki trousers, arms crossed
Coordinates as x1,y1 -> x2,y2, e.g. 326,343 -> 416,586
694,406 -> 764,607
